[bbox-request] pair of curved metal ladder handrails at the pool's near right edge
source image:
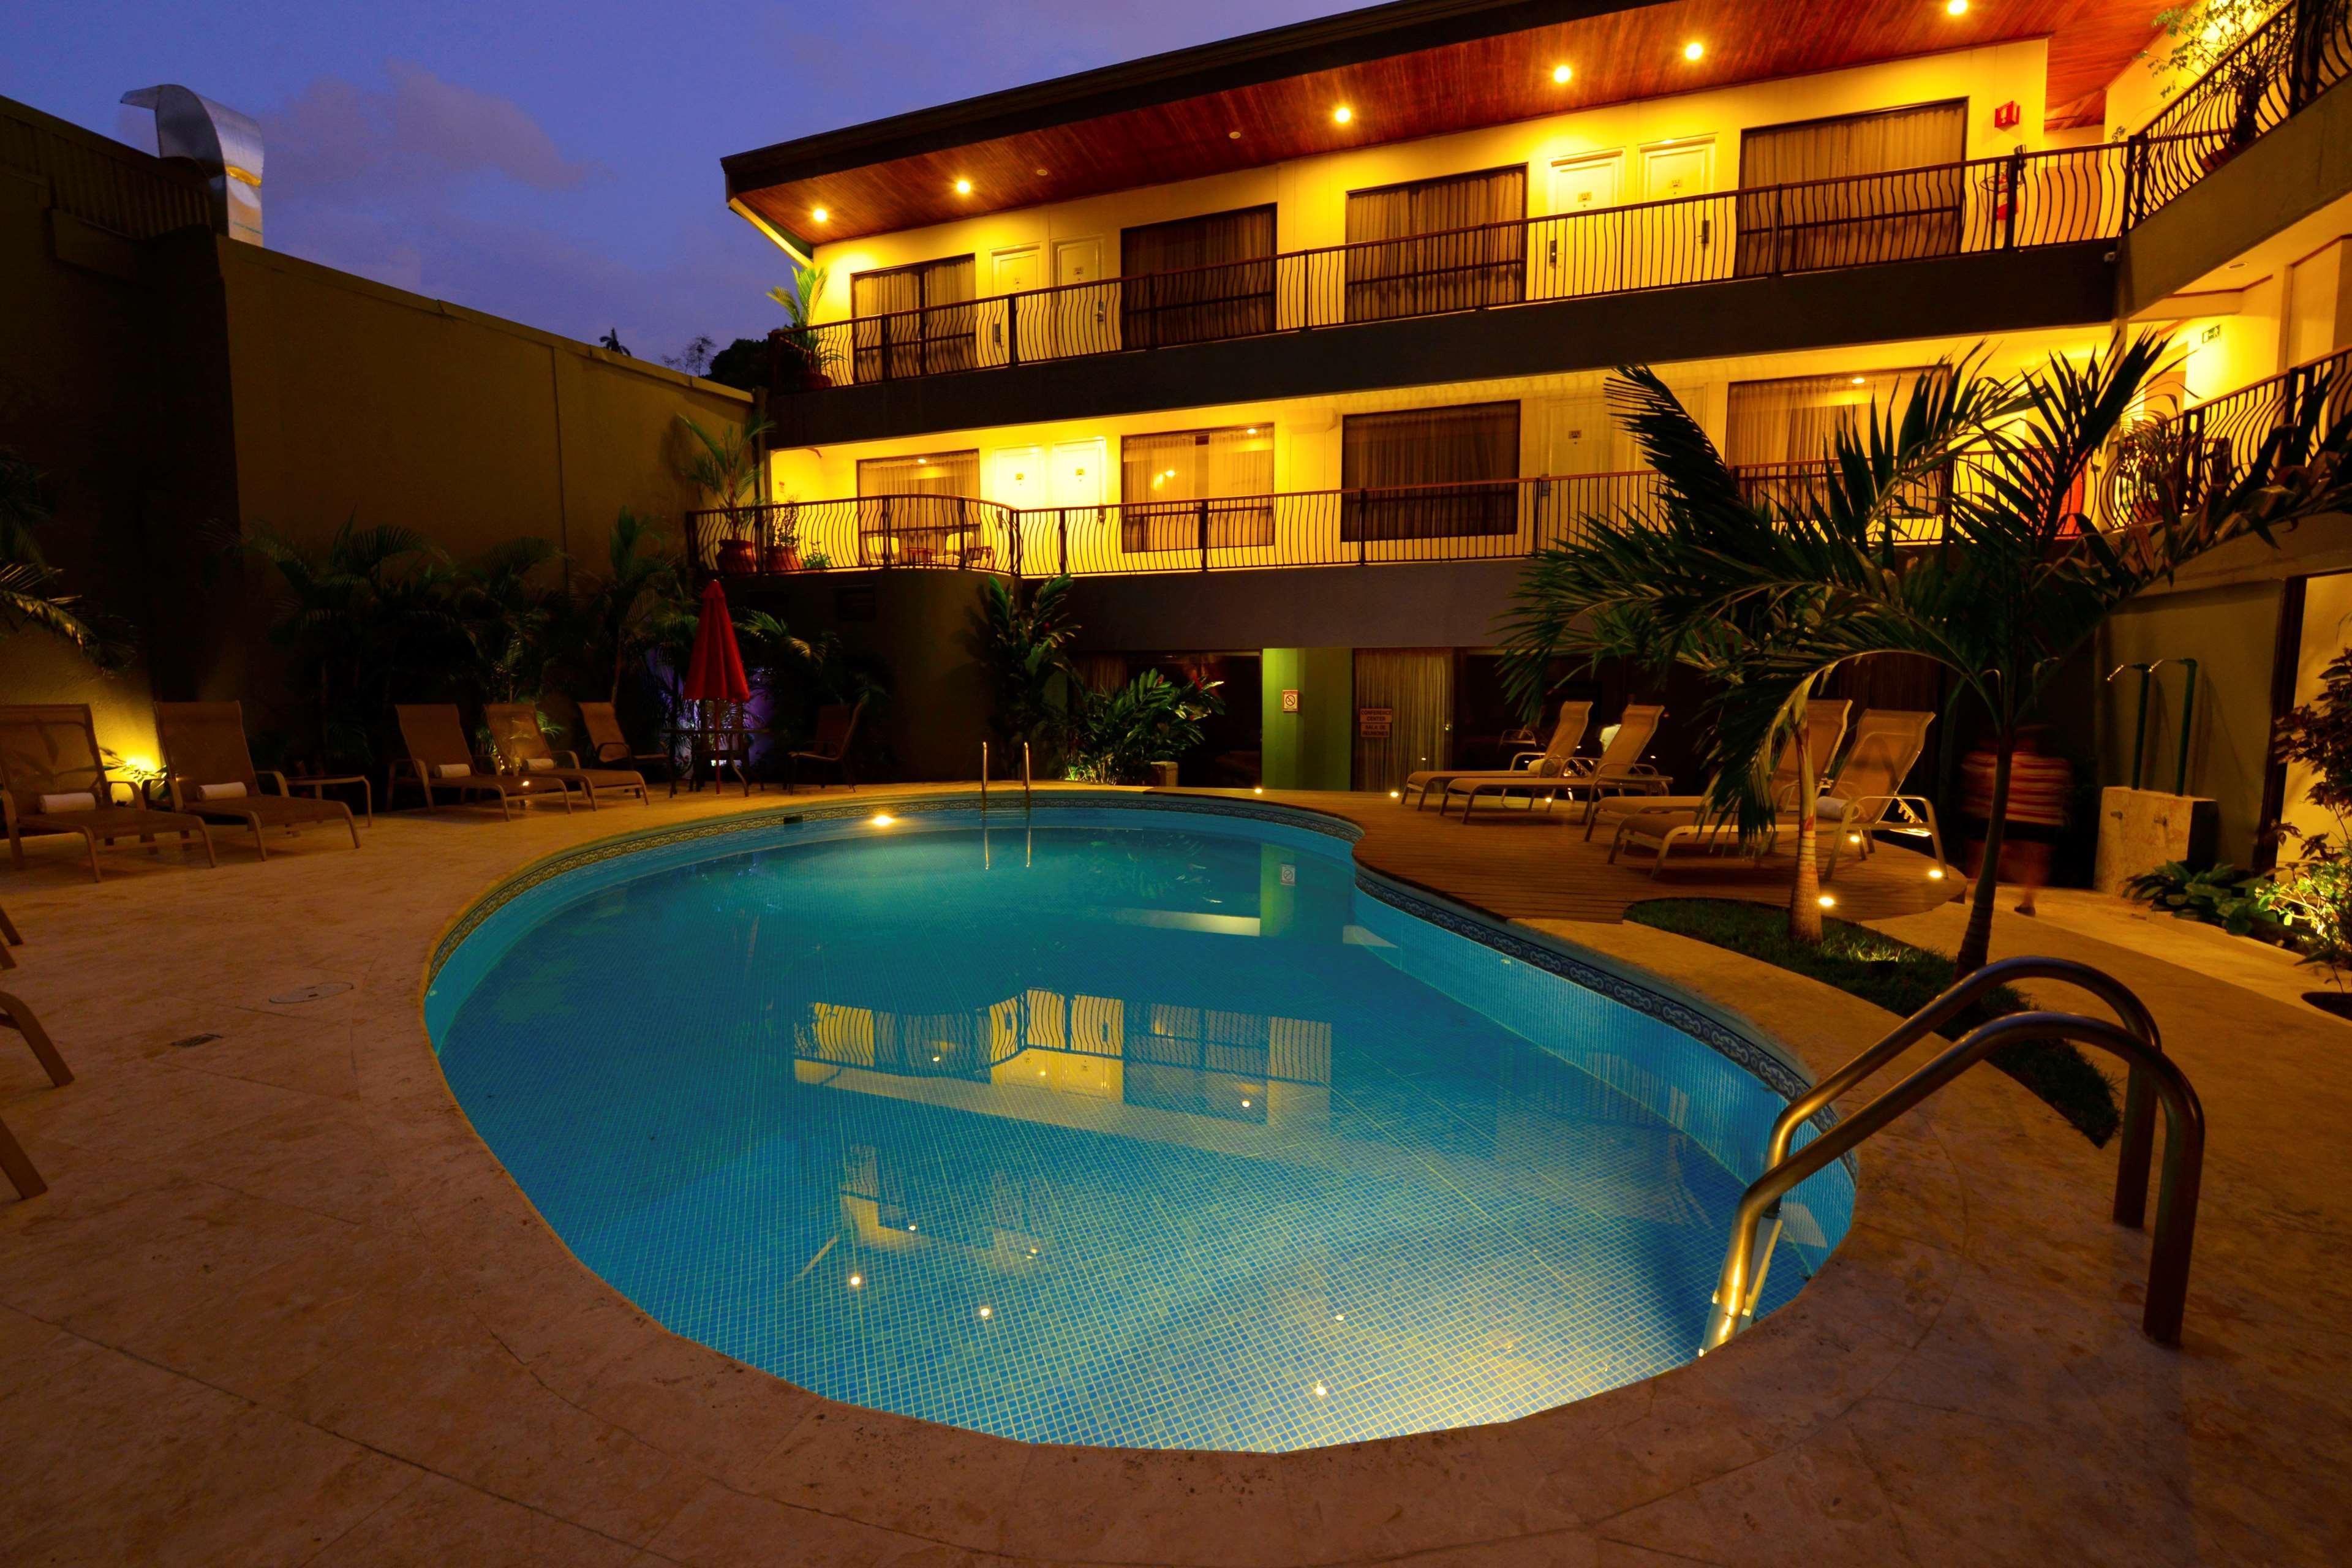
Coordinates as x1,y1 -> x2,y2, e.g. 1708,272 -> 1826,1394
1698,957 -> 2204,1354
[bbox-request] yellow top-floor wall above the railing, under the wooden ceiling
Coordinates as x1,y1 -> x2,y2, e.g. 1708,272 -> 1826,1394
816,40 -> 2046,320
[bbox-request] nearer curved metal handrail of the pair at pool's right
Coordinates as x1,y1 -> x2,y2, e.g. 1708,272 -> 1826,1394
1698,1004 -> 2204,1354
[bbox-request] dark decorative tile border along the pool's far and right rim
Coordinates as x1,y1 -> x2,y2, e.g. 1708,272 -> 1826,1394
426,790 -> 1851,1166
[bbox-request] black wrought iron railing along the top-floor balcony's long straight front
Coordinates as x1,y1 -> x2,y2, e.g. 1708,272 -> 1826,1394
780,132 -> 2145,383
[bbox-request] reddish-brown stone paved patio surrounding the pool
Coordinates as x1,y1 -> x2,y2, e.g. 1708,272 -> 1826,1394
0,797 -> 2352,1568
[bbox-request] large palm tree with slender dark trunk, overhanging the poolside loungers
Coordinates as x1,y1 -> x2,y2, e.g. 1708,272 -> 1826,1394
1515,334 -> 2352,976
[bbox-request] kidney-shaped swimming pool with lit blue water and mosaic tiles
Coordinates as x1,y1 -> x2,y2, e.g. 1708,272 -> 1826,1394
426,794 -> 1853,1450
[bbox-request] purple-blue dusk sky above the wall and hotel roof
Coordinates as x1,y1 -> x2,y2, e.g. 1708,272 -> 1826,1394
0,0 -> 1350,357
